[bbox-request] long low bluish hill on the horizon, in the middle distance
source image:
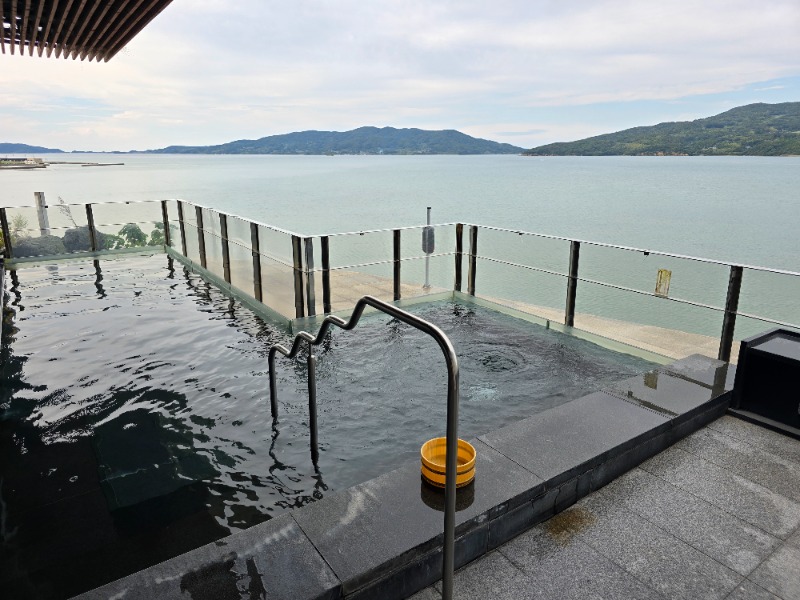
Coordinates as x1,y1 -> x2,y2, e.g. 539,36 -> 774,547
142,127 -> 524,154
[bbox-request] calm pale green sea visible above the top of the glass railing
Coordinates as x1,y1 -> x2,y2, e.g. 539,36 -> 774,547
0,154 -> 800,270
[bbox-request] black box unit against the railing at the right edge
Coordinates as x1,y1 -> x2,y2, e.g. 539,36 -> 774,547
731,329 -> 800,439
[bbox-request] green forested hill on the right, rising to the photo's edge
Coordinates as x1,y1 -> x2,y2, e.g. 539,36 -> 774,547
523,102 -> 800,156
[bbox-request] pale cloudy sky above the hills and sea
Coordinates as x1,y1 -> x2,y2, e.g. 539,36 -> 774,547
0,0 -> 800,151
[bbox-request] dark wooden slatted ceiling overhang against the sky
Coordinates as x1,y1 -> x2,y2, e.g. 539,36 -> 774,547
0,0 -> 172,61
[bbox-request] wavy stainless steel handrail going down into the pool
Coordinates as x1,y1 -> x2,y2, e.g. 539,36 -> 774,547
268,296 -> 458,600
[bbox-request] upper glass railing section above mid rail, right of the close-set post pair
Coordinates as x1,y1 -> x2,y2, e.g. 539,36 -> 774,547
472,227 -> 570,274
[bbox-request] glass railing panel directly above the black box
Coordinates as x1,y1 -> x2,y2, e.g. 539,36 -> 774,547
735,269 -> 800,340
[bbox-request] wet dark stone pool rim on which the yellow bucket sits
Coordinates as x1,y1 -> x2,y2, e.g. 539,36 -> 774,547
78,355 -> 734,599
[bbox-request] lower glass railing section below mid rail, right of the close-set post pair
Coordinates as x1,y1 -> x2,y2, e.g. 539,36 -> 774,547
476,258 -> 567,323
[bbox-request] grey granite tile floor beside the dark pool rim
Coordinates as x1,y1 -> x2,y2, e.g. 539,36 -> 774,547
412,416 -> 800,600
